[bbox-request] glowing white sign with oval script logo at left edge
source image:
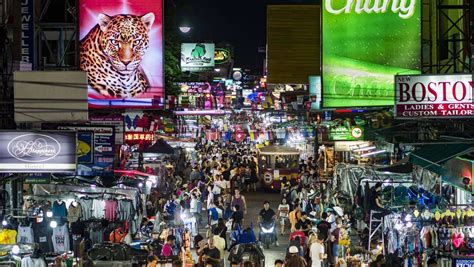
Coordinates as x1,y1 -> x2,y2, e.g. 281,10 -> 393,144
0,131 -> 76,173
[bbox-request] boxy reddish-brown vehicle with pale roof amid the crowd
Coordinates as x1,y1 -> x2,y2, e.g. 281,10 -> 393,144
258,145 -> 300,190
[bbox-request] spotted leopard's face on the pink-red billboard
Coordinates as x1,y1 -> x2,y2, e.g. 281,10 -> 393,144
98,13 -> 155,75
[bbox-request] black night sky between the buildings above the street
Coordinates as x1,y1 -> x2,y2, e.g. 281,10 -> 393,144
179,0 -> 320,74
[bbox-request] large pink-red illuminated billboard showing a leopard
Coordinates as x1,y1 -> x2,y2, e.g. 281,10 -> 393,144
79,0 -> 164,108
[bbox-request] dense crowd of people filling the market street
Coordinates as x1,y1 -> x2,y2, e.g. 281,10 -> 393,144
142,142 -> 347,266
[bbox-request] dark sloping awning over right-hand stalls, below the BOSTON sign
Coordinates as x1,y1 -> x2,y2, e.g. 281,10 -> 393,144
410,144 -> 474,175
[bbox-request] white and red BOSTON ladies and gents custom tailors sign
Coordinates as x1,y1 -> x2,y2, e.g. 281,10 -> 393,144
395,74 -> 474,119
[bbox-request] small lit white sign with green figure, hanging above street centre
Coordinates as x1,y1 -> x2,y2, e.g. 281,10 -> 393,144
181,43 -> 215,71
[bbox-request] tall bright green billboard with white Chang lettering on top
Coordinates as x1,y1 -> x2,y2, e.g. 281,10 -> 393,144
322,0 -> 421,108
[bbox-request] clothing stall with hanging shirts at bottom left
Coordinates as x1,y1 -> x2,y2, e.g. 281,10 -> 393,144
0,184 -> 146,266
